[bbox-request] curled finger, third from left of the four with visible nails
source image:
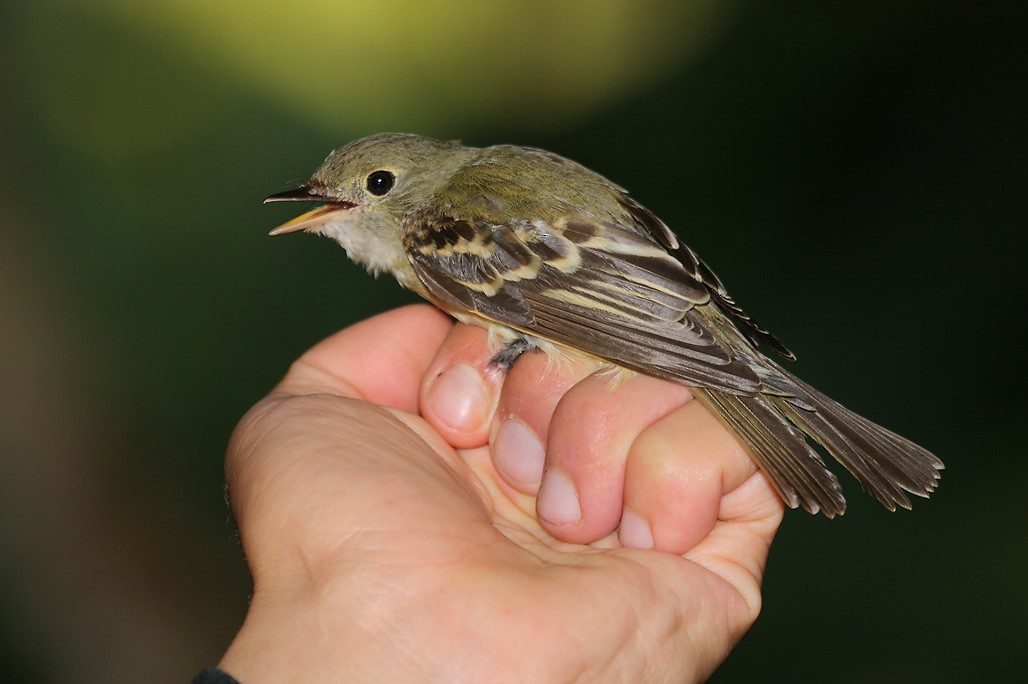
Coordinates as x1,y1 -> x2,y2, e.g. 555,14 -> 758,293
537,371 -> 692,543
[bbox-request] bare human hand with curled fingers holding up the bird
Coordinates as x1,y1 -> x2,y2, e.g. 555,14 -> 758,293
220,305 -> 783,684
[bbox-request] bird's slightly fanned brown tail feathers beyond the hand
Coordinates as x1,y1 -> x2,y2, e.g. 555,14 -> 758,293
694,363 -> 944,517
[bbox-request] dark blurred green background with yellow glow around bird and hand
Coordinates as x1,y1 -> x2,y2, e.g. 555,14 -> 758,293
0,0 -> 1028,683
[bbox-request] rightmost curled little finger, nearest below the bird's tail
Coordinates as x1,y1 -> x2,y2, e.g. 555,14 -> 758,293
620,401 -> 757,554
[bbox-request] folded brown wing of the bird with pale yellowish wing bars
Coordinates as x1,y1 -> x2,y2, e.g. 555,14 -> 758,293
404,197 -> 783,395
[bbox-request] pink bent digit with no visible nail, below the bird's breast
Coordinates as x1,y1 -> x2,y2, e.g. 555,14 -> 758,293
274,304 -> 452,412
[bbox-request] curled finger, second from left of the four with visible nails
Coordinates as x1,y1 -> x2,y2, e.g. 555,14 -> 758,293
490,352 -> 596,493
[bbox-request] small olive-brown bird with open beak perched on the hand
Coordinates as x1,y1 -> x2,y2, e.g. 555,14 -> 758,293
265,134 -> 944,517
